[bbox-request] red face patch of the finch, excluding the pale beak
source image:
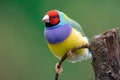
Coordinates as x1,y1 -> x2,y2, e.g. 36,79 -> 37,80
47,10 -> 59,25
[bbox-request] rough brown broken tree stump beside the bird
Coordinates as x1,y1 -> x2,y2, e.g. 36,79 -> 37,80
90,29 -> 120,80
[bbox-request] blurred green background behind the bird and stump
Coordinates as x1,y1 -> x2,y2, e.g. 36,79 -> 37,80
0,0 -> 120,80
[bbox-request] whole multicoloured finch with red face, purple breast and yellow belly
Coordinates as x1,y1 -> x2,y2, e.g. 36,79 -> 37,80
42,10 -> 91,73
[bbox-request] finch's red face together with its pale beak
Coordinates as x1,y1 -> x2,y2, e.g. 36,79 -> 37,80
42,10 -> 60,26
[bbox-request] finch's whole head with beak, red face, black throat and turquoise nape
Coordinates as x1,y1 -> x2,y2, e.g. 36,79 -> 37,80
42,10 -> 69,27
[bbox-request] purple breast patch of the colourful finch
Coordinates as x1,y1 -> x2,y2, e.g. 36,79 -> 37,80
44,24 -> 72,44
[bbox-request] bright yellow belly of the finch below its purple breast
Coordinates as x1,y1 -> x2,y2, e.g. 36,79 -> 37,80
48,28 -> 88,58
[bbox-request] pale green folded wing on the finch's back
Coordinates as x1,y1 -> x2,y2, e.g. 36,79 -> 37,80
68,18 -> 85,37
